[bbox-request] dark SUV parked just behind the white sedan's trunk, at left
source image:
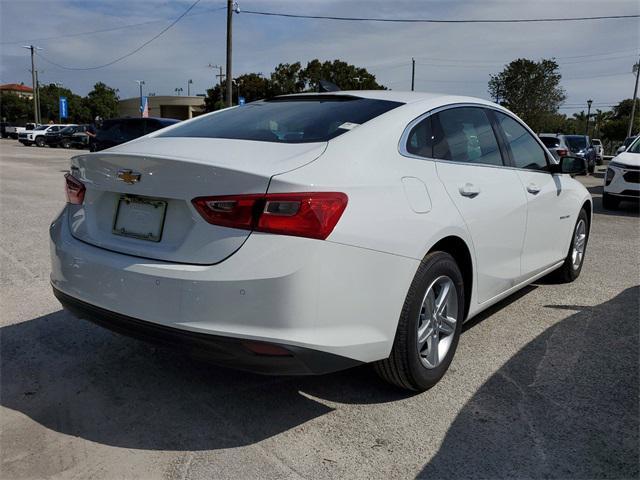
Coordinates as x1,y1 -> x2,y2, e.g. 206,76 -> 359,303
91,118 -> 180,152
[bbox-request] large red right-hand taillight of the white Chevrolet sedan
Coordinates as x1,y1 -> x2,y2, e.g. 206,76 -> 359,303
192,192 -> 348,240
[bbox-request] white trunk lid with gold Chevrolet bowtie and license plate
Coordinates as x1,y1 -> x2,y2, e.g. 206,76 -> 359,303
69,138 -> 326,264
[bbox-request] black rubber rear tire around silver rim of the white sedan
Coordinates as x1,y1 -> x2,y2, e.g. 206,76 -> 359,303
374,252 -> 465,391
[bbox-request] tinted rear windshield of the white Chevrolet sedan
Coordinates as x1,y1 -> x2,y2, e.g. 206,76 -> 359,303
159,95 -> 402,143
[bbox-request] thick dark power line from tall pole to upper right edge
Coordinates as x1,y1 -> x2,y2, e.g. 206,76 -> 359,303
242,10 -> 640,23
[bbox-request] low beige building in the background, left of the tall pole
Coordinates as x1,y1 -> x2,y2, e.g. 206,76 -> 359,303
118,95 -> 204,120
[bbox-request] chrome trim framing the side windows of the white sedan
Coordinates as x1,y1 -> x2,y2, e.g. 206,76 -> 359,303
398,102 -> 556,175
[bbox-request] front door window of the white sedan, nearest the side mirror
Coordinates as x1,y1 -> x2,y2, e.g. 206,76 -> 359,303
494,112 -> 547,170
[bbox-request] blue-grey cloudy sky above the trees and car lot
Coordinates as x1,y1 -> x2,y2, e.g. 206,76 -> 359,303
0,0 -> 640,114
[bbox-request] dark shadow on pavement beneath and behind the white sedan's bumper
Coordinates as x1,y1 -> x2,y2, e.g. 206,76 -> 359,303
0,310 -> 410,451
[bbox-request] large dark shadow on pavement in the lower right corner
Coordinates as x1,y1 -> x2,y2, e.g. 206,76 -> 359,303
420,287 -> 640,479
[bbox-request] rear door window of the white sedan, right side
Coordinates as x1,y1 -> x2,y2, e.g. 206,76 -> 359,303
431,107 -> 503,165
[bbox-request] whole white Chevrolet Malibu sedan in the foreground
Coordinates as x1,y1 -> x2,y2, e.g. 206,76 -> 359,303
50,91 -> 592,390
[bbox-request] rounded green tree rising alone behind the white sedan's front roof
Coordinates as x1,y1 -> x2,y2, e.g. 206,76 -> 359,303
489,58 -> 566,132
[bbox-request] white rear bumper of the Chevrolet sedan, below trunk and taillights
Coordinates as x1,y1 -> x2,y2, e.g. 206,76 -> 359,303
50,209 -> 420,362
